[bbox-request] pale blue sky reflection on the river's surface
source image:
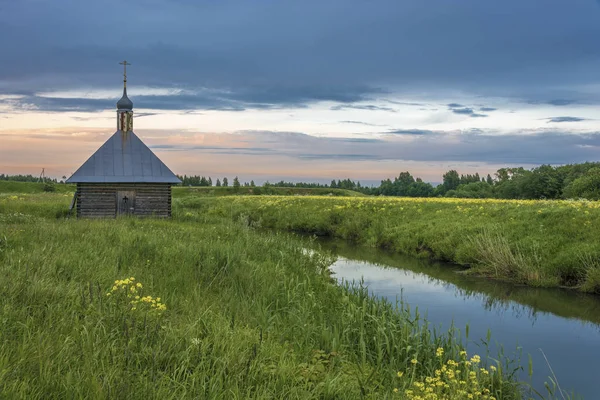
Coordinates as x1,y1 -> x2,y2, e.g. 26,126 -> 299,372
331,258 -> 600,399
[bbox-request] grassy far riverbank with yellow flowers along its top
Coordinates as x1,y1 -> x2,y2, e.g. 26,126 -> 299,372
182,197 -> 600,293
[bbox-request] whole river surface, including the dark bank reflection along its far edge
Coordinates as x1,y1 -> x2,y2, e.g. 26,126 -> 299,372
319,240 -> 600,399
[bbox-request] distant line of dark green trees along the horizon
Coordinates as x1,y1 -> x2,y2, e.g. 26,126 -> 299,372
0,162 -> 600,200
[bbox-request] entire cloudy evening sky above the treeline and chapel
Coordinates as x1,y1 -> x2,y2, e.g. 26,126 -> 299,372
0,0 -> 600,184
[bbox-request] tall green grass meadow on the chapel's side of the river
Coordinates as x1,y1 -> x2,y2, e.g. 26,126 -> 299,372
0,184 -> 556,399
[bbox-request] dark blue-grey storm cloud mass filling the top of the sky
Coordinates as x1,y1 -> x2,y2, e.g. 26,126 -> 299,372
0,0 -> 600,109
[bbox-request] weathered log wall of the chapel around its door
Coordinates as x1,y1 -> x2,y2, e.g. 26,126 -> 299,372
77,183 -> 171,218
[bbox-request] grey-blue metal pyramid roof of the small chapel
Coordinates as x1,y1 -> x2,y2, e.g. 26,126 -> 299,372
67,131 -> 181,183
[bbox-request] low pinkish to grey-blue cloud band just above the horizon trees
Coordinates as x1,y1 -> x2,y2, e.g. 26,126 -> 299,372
7,128 -> 600,181
